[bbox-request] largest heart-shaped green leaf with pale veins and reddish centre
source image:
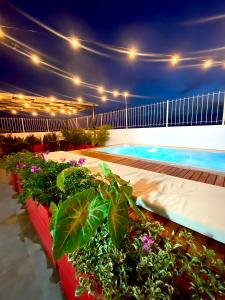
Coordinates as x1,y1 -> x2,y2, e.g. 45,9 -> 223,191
53,189 -> 110,259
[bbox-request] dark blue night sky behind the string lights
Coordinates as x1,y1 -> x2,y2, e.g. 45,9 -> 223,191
0,0 -> 225,115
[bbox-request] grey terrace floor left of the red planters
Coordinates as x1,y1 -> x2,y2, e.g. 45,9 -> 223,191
0,169 -> 64,300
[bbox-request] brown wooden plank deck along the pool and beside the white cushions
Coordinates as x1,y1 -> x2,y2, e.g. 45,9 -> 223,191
76,150 -> 225,262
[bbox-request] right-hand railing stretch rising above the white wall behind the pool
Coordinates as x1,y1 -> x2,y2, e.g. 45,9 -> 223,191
72,91 -> 225,129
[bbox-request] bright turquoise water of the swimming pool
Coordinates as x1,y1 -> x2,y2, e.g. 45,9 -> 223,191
98,145 -> 225,172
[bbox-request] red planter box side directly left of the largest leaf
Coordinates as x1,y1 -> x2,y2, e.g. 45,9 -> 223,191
26,199 -> 55,266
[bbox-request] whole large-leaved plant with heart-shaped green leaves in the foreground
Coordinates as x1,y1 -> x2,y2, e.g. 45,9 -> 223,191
53,163 -> 145,259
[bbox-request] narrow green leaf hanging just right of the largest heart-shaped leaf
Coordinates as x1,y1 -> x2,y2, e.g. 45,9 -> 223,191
108,193 -> 129,247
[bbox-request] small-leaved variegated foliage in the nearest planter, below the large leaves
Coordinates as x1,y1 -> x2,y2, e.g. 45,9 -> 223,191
69,221 -> 225,300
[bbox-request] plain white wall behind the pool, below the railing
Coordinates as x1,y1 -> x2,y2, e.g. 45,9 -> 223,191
107,125 -> 225,150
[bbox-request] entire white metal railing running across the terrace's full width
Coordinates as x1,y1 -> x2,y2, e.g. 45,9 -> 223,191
0,91 -> 225,132
